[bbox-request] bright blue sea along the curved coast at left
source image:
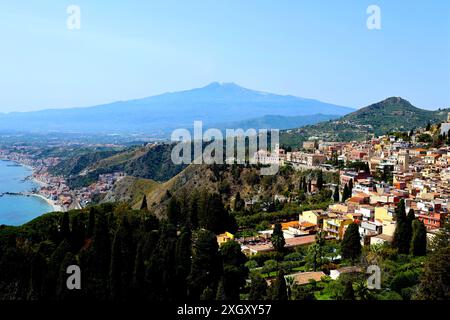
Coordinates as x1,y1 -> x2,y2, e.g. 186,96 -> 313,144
0,160 -> 53,226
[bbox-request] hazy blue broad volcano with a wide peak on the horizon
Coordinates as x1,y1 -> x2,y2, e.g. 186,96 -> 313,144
0,82 -> 354,136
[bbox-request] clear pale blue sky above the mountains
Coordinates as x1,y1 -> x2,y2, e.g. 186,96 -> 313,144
0,0 -> 450,112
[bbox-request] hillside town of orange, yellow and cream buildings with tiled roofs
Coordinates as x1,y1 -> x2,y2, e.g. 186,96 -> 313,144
243,114 -> 450,254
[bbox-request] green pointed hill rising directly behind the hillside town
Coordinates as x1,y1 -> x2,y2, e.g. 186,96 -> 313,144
280,97 -> 450,147
